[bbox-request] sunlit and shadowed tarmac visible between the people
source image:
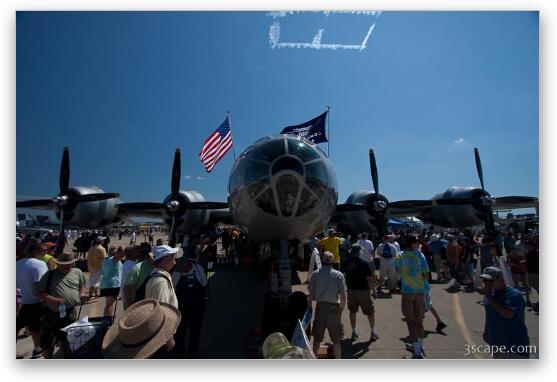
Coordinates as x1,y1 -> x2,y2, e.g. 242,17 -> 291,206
16,236 -> 539,360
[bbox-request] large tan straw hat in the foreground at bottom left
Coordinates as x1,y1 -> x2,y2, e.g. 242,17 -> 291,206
102,299 -> 181,359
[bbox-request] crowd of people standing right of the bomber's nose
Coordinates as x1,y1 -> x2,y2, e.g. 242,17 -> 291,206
307,225 -> 539,359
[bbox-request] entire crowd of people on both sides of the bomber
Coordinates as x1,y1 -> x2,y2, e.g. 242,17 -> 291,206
16,222 -> 539,358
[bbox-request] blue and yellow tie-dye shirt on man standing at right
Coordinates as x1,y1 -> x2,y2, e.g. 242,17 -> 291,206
394,251 -> 429,293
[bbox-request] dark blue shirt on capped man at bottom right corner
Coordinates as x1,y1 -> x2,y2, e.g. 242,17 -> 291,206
484,287 -> 530,350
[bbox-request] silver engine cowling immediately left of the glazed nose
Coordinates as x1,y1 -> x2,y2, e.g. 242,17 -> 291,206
163,190 -> 210,235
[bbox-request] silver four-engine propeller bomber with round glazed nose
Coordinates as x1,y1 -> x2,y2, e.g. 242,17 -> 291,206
16,134 -> 538,251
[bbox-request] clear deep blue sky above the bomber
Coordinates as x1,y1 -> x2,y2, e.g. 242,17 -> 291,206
16,12 -> 539,213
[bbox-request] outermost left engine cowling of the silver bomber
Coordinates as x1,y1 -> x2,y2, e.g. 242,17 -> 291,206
54,186 -> 119,228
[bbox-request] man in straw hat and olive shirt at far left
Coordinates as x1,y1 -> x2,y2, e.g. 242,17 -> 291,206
37,253 -> 87,358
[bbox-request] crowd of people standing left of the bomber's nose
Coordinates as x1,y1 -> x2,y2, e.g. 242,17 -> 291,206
16,228 -> 207,358
